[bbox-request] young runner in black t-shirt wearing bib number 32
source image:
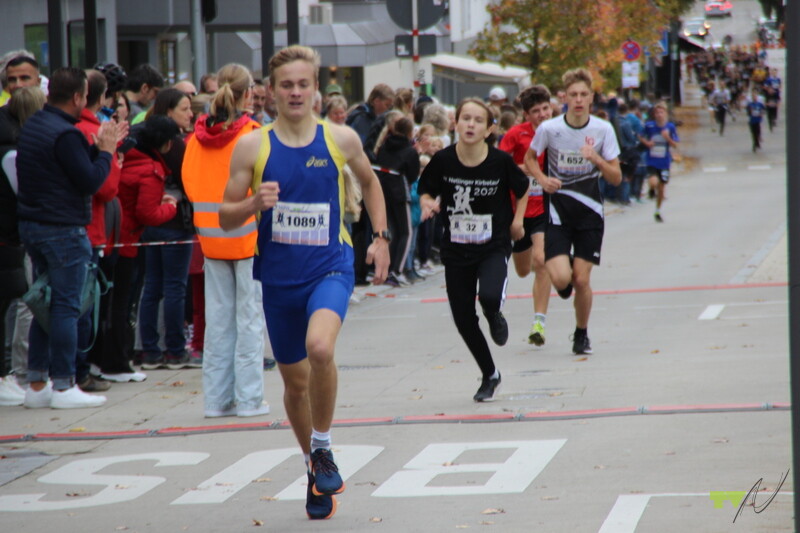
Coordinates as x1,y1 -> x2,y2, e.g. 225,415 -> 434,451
412,98 -> 529,402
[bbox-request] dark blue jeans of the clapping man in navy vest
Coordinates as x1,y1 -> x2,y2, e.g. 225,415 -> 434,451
19,220 -> 92,390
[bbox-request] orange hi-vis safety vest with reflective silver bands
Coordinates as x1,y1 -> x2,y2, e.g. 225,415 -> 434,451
181,121 -> 261,260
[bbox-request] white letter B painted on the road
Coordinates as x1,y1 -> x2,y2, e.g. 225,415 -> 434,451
372,439 -> 567,498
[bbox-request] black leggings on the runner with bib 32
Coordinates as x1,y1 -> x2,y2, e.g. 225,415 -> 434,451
444,251 -> 508,378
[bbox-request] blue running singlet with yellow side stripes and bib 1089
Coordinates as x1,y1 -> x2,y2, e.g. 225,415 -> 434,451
252,121 -> 353,287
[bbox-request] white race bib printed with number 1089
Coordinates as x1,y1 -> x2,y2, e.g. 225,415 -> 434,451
272,202 -> 331,246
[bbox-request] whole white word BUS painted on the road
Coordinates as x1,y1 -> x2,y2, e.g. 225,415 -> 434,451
0,439 -> 567,512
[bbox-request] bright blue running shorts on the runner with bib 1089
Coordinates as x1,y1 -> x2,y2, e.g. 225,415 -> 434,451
262,272 -> 355,365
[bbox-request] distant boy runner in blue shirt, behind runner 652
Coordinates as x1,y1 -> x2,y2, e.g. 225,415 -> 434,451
639,102 -> 680,222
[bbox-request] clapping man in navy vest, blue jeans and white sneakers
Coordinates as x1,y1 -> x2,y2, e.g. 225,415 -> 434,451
17,67 -> 119,409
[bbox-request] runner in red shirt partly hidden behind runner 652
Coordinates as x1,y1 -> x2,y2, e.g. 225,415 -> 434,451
500,85 -> 553,346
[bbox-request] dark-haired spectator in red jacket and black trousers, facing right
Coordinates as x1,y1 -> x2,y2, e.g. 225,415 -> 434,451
112,116 -> 179,373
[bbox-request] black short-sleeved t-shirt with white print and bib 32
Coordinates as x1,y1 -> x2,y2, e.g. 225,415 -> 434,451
418,145 -> 530,265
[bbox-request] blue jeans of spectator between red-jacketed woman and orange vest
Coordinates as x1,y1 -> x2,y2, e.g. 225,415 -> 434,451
139,227 -> 192,356
